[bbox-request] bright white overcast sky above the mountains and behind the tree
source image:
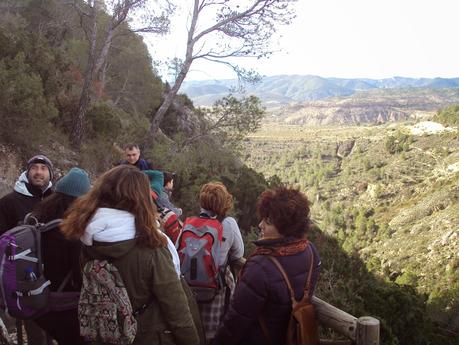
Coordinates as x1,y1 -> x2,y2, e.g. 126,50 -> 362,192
146,0 -> 459,81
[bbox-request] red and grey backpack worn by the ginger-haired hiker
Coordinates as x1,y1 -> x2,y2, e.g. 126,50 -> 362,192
176,216 -> 223,302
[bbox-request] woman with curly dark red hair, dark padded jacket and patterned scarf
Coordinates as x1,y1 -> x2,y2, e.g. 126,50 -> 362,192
213,187 -> 320,345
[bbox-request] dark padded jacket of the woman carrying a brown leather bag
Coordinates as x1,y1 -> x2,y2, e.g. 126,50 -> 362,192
212,238 -> 320,345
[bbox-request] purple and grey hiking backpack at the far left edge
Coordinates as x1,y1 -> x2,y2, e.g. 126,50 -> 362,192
0,215 -> 79,320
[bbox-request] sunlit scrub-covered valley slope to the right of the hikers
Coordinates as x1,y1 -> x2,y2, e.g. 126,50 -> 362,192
245,122 -> 459,338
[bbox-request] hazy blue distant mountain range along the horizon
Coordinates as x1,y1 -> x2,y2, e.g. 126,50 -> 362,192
180,75 -> 459,108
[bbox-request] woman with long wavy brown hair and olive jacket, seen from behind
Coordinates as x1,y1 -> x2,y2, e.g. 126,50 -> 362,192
61,165 -> 199,345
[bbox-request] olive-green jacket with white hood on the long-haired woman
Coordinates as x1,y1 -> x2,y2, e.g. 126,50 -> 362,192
82,210 -> 199,345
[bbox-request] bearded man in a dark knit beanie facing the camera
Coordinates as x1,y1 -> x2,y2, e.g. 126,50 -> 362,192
0,155 -> 53,345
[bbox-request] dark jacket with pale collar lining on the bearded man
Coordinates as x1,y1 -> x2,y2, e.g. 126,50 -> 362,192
0,172 -> 52,234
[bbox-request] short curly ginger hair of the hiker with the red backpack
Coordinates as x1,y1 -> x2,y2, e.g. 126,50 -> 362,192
199,182 -> 233,218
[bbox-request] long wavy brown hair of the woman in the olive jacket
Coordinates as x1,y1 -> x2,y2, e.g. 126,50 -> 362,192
61,165 -> 167,248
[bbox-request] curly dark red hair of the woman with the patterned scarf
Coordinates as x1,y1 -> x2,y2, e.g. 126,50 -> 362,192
257,187 -> 310,237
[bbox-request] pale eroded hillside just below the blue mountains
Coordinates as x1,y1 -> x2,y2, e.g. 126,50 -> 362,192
280,89 -> 459,126
